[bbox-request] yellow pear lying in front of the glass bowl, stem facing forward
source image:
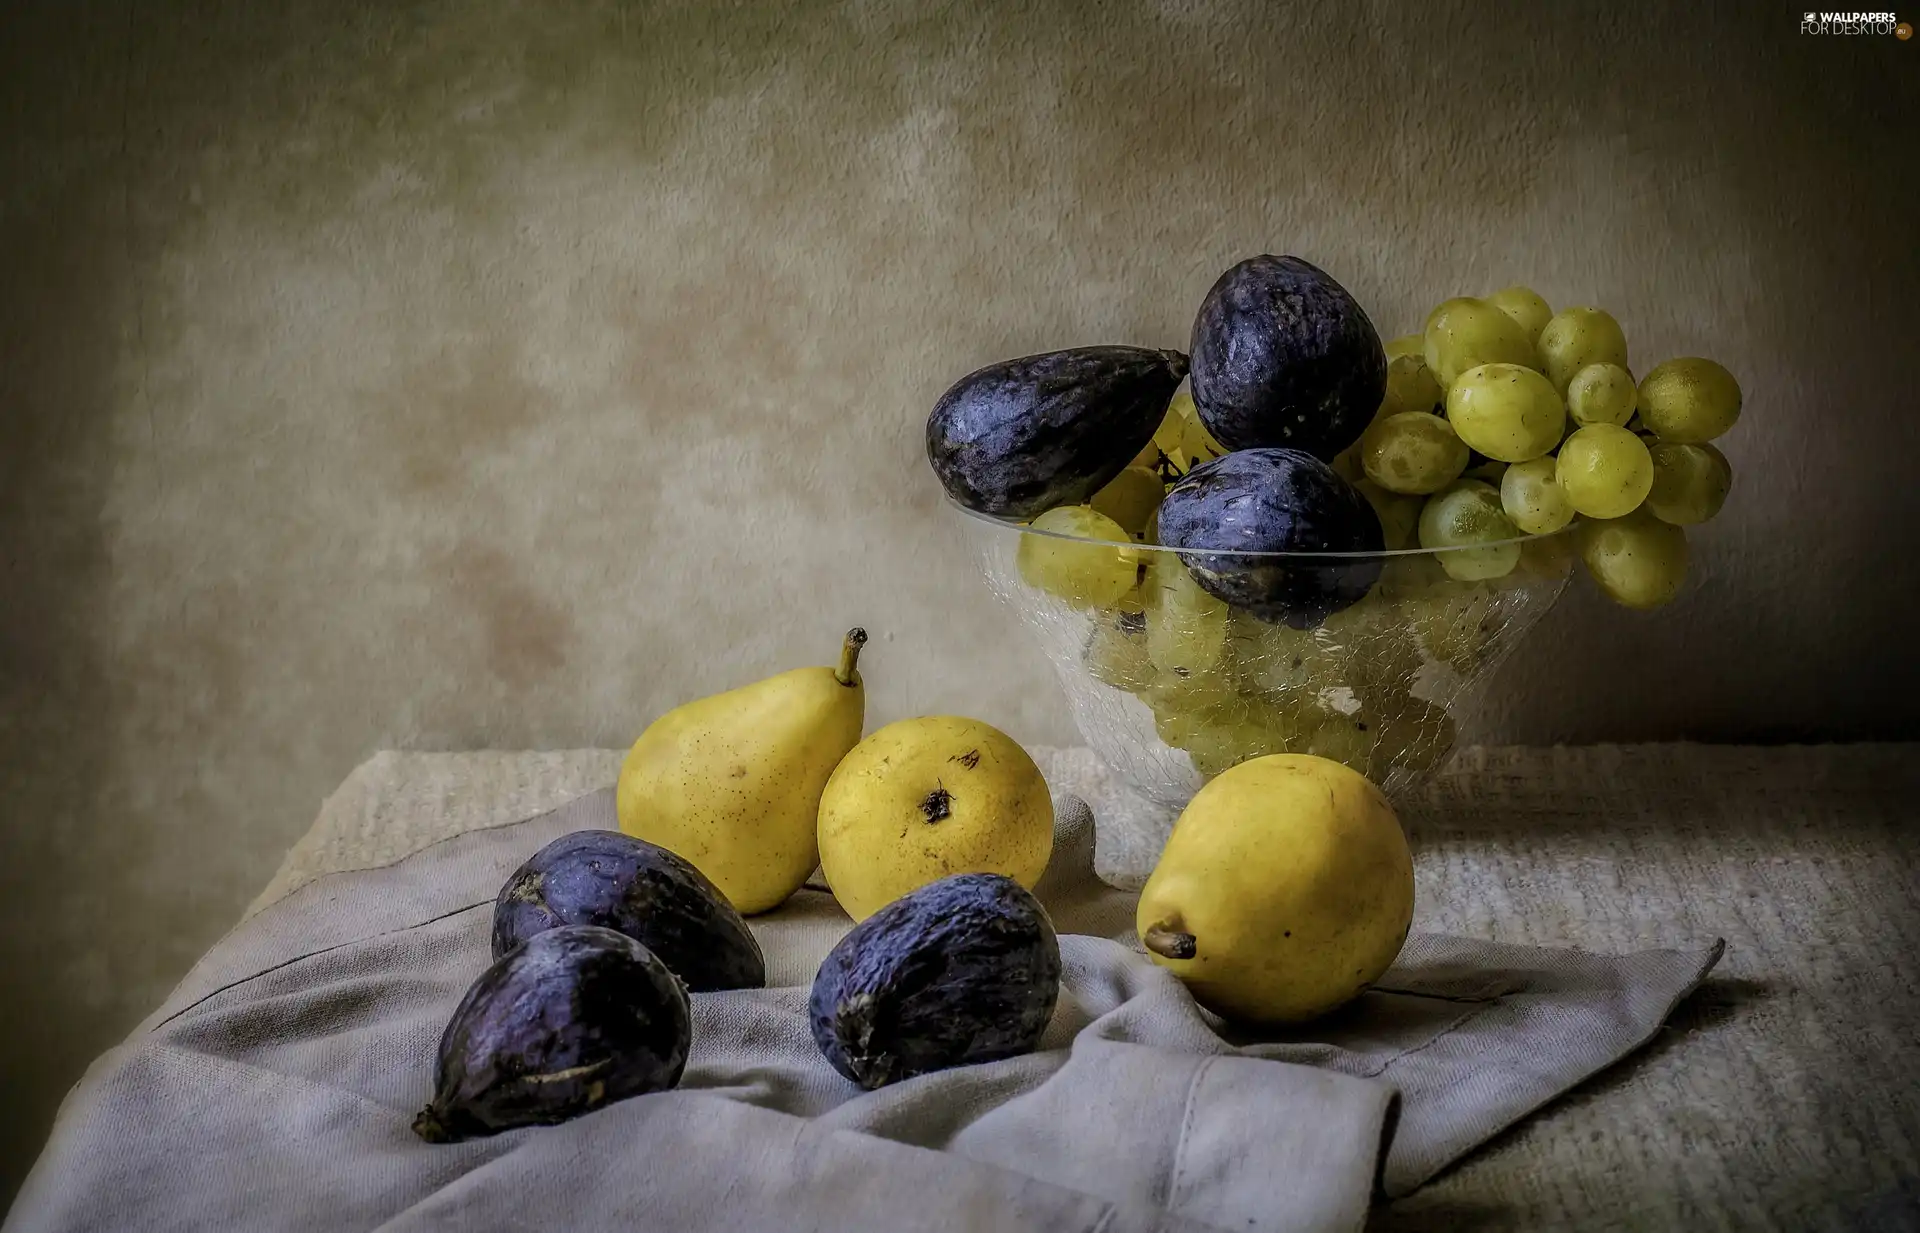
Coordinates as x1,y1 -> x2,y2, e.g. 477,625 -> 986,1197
1135,753 -> 1413,1024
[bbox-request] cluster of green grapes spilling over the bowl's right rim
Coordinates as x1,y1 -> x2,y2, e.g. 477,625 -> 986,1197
1390,286 -> 1741,609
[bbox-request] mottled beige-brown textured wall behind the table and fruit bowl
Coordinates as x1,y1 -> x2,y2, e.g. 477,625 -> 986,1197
0,0 -> 1920,1198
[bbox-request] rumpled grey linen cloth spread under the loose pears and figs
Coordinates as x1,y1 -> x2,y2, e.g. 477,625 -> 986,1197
6,776 -> 1720,1233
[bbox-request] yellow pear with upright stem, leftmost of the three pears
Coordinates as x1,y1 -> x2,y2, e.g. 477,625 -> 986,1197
616,630 -> 866,914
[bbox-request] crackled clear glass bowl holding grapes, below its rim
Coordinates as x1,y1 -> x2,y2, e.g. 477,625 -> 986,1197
948,499 -> 1574,855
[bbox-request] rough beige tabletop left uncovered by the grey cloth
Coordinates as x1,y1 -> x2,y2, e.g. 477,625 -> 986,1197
250,743 -> 1920,1229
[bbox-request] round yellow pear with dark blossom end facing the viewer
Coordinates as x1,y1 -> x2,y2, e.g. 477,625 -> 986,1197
820,714 -> 1054,920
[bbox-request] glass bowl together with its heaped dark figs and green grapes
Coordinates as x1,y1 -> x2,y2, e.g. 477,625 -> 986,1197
925,255 -> 1741,806
